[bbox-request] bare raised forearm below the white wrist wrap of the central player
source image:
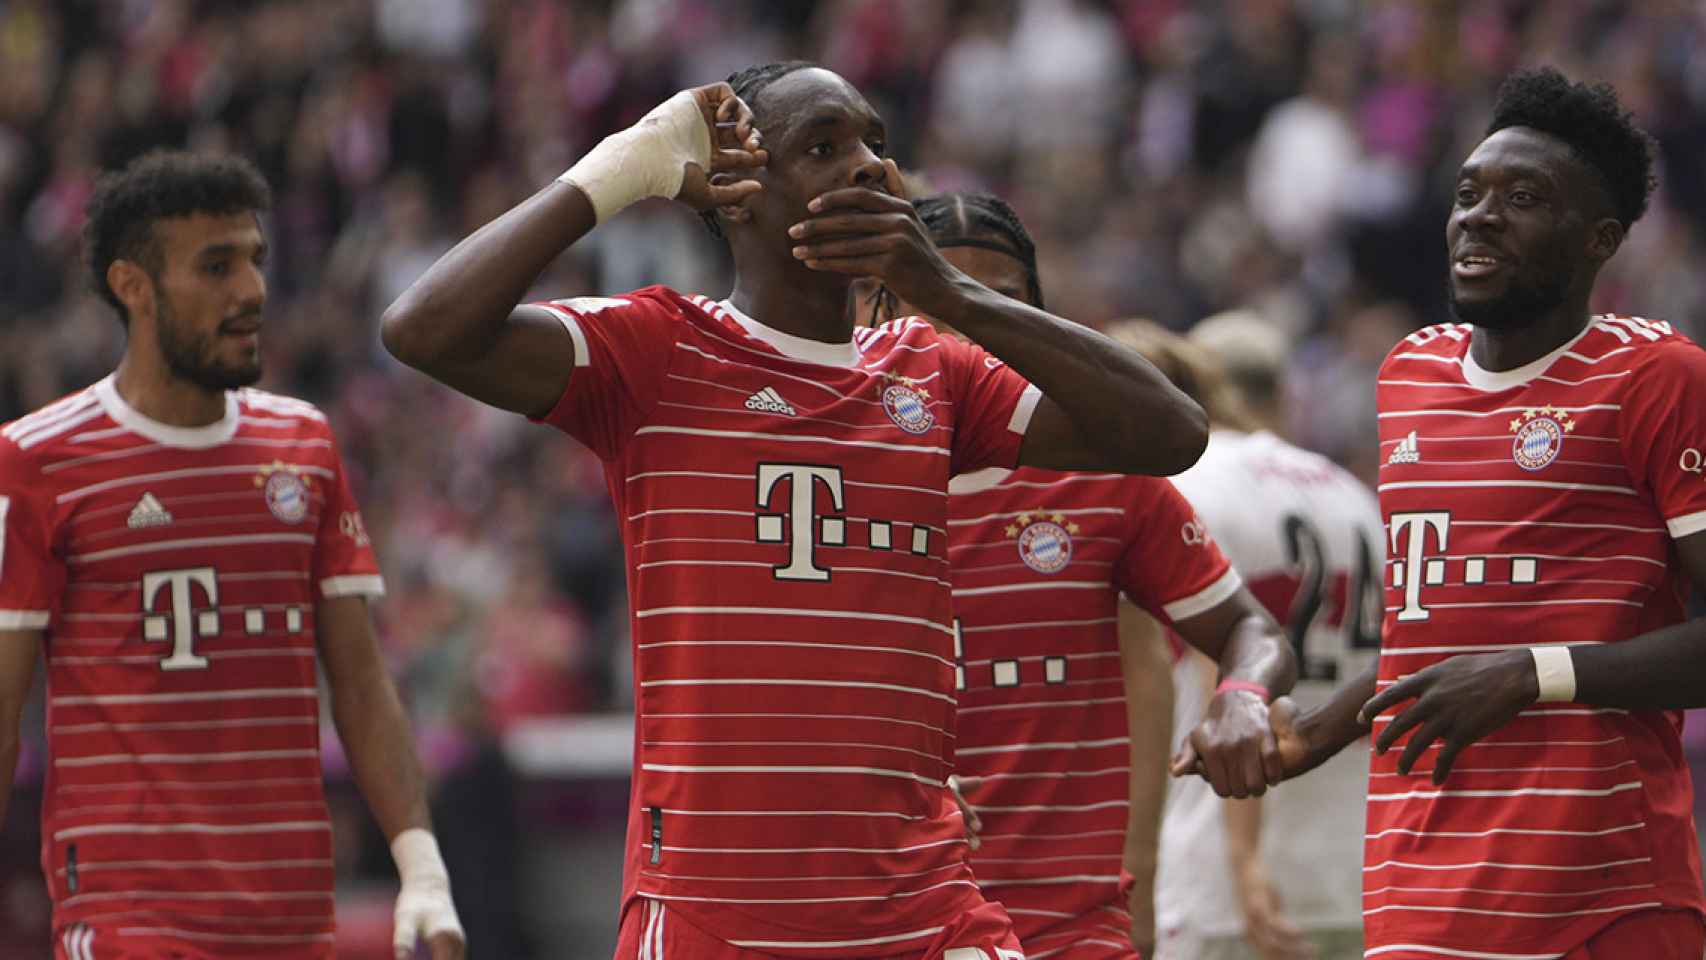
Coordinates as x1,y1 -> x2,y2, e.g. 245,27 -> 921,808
380,181 -> 597,373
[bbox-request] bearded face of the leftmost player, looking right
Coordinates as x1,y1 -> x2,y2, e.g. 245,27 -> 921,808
154,213 -> 266,390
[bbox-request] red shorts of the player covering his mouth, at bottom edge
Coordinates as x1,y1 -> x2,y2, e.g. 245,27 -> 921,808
616,897 -> 1025,960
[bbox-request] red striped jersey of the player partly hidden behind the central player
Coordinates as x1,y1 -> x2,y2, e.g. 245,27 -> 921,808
949,469 -> 1240,958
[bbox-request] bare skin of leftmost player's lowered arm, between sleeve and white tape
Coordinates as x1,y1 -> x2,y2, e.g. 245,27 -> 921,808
316,597 -> 432,839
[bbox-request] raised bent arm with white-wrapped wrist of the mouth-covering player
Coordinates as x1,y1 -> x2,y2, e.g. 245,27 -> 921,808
380,84 -> 763,416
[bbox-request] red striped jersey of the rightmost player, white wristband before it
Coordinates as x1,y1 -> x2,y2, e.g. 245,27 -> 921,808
1363,317 -> 1706,957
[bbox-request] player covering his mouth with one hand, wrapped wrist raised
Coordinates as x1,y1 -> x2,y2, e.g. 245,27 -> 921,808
384,61 -> 1280,960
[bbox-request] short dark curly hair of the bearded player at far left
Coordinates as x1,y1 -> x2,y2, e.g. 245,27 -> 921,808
84,150 -> 273,324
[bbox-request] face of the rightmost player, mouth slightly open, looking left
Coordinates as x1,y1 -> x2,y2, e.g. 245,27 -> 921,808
1445,126 -> 1599,329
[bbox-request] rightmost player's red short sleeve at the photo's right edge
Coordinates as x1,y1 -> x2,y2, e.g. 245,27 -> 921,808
1619,338 -> 1706,539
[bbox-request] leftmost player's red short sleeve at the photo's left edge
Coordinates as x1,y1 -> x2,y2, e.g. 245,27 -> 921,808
0,440 -> 65,629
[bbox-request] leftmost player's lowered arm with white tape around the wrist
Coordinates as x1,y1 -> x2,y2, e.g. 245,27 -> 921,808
316,597 -> 464,960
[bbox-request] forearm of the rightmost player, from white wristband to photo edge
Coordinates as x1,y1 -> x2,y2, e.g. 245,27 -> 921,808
1570,617 -> 1706,711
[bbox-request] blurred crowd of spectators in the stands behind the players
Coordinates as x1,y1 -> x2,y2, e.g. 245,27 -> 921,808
0,0 -> 1706,732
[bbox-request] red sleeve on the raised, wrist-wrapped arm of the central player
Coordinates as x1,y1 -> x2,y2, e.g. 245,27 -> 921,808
534,286 -> 682,460
